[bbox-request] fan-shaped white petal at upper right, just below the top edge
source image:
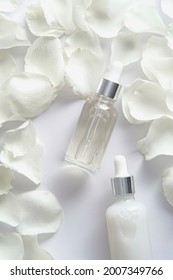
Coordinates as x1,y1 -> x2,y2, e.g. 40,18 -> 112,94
125,2 -> 167,35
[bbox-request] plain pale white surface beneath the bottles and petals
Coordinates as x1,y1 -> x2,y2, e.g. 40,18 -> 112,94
0,1 -> 173,260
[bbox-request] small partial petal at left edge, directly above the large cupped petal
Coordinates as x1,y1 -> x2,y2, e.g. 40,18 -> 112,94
0,50 -> 16,85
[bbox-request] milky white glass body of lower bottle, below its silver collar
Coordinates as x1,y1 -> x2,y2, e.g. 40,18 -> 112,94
106,197 -> 152,260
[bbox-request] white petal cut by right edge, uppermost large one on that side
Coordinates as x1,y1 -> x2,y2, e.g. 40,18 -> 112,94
141,37 -> 173,90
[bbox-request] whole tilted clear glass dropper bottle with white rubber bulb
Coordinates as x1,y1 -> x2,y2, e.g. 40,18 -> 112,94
65,64 -> 122,171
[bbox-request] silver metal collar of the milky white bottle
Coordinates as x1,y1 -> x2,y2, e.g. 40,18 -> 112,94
111,176 -> 135,196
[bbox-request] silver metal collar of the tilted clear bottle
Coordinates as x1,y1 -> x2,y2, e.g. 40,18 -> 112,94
97,79 -> 122,99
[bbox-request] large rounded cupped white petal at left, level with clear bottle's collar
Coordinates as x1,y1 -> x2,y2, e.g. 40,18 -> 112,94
3,73 -> 57,119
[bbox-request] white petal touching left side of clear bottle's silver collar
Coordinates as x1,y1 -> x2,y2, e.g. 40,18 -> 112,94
65,50 -> 105,97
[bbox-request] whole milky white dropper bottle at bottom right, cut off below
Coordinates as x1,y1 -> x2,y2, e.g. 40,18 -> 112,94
106,155 -> 152,260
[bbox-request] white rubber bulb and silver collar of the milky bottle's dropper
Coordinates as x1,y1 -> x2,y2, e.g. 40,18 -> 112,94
111,155 -> 135,196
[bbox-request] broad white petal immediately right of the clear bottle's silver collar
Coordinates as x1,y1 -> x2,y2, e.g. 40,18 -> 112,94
122,79 -> 173,124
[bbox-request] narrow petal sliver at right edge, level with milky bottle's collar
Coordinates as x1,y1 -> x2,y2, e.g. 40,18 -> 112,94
162,167 -> 173,206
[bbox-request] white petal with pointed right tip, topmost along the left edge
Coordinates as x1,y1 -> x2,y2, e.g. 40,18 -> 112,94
0,14 -> 30,49
